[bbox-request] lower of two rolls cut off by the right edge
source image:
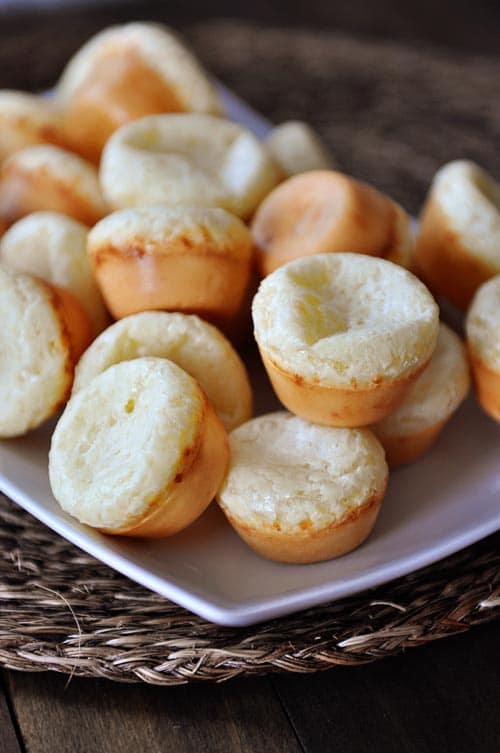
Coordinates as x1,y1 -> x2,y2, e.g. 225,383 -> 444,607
465,275 -> 500,421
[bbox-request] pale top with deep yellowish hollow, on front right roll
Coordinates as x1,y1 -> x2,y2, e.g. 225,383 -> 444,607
252,253 -> 439,388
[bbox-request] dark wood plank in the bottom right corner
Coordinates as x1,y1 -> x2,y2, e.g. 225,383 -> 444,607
273,623 -> 500,753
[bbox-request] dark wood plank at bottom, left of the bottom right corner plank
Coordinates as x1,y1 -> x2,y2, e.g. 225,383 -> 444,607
5,673 -> 301,753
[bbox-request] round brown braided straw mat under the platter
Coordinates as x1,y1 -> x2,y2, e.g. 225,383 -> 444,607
0,22 -> 500,685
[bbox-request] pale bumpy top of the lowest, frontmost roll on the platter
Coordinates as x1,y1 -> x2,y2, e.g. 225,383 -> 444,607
218,412 -> 387,534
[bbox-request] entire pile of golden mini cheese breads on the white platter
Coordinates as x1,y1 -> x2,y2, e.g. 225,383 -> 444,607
0,23 -> 500,563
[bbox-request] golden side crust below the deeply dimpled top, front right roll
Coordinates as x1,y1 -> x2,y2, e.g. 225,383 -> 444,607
259,347 -> 429,427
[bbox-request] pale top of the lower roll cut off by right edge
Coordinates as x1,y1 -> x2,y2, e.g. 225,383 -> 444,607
466,275 -> 500,371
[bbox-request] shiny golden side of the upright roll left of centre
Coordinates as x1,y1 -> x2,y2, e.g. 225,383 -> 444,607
90,245 -> 252,328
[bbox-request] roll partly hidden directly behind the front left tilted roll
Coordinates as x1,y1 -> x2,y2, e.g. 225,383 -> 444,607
73,311 -> 252,431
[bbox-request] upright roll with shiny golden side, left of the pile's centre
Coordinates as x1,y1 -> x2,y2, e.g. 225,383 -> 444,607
88,206 -> 253,328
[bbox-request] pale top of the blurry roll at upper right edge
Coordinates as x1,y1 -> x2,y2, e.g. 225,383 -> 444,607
431,160 -> 500,271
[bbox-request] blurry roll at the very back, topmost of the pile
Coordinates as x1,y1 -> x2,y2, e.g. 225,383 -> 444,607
57,23 -> 222,161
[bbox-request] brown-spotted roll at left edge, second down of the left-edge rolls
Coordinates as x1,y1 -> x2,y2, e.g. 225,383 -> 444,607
0,144 -> 106,225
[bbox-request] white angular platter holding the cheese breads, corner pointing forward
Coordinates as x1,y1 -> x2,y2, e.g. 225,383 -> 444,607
0,85 -> 500,626
